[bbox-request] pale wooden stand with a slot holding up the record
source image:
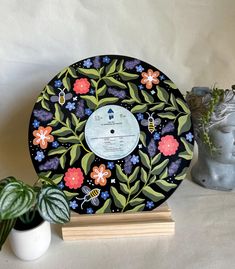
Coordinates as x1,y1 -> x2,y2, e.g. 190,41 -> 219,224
62,203 -> 175,241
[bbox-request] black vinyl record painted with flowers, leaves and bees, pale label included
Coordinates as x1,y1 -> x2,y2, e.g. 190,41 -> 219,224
29,55 -> 194,214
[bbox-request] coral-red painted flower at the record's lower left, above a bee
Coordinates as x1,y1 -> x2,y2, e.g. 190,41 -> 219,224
64,168 -> 84,189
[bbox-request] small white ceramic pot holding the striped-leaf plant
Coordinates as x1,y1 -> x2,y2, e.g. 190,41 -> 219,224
9,221 -> 51,261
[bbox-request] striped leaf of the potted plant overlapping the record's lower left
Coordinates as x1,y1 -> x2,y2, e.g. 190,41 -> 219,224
37,186 -> 70,223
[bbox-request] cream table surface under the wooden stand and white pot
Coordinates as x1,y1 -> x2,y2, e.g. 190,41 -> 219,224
0,179 -> 235,269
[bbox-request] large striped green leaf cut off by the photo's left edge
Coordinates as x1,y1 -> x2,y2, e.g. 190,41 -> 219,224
0,181 -> 35,220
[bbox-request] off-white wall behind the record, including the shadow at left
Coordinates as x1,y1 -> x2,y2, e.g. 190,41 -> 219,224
0,0 -> 235,181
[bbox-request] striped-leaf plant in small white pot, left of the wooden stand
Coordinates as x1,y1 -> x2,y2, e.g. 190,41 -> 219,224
0,174 -> 70,260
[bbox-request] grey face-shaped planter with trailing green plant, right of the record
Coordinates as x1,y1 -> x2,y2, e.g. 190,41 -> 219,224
187,87 -> 235,191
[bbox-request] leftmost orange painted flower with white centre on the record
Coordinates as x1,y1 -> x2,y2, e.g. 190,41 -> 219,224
33,126 -> 54,149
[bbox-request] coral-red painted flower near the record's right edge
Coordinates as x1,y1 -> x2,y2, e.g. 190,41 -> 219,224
158,135 -> 179,156
